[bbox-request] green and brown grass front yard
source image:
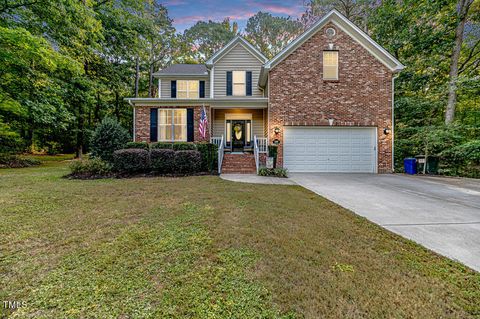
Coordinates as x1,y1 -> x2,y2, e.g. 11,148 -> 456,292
0,158 -> 480,319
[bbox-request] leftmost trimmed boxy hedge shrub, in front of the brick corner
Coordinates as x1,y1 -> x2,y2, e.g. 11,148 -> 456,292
113,148 -> 149,174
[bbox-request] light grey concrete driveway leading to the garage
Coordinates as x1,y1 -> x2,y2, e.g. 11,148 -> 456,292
290,173 -> 480,271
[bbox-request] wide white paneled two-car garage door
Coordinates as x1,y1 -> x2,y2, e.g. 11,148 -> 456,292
283,126 -> 377,173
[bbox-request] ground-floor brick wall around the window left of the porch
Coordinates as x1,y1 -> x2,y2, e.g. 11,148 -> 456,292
135,105 -> 211,142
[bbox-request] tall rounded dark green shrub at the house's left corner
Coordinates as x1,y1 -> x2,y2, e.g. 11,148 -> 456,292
91,117 -> 130,162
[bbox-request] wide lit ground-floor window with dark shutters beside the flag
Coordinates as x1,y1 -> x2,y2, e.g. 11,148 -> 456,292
158,109 -> 187,142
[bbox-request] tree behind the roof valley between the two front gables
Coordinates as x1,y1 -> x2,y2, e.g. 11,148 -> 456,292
245,12 -> 303,58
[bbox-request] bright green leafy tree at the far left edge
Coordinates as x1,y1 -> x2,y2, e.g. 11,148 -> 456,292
0,27 -> 82,151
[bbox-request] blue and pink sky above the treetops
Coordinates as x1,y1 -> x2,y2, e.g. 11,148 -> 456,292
161,0 -> 305,32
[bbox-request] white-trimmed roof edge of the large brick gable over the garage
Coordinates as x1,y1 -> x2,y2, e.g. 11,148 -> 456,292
259,9 -> 404,86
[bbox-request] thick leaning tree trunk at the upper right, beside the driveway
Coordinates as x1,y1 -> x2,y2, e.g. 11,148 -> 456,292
445,0 -> 473,124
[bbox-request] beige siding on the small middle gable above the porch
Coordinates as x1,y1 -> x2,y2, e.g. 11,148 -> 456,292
213,43 -> 263,98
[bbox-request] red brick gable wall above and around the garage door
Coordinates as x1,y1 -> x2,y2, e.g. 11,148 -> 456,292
268,24 -> 393,173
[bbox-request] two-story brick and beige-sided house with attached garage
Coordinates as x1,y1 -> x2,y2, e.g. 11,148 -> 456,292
127,10 -> 403,173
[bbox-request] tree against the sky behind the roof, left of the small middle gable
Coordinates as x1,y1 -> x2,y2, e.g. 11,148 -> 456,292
183,18 -> 238,63
